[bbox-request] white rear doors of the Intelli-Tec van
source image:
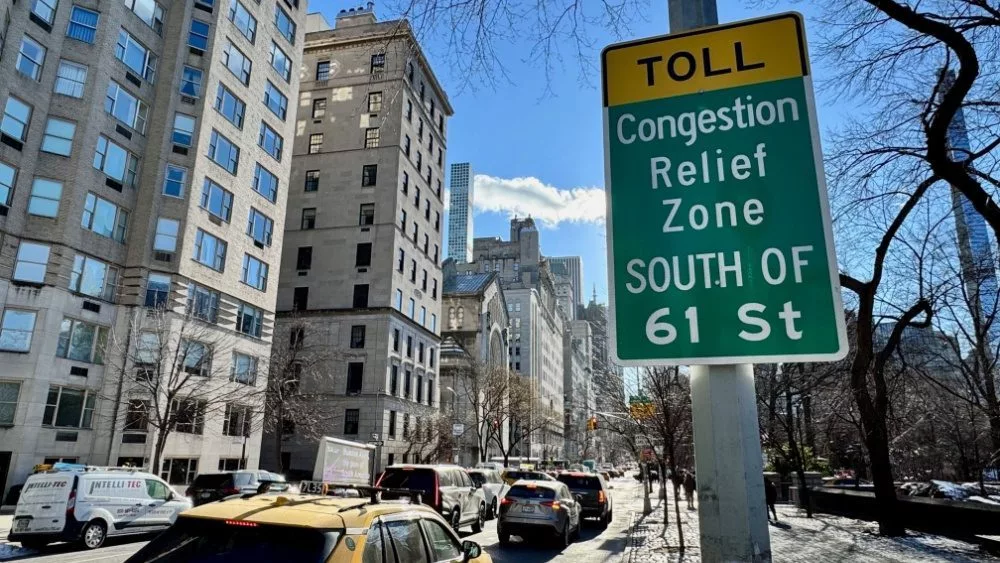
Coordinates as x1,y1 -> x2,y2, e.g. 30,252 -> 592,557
11,473 -> 76,534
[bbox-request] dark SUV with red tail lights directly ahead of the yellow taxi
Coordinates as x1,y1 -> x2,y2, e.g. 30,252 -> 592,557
377,465 -> 486,534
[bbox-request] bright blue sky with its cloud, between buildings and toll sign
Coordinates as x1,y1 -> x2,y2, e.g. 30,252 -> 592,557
320,0 -> 837,302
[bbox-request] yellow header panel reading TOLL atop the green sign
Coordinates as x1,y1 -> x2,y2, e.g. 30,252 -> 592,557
601,13 -> 809,107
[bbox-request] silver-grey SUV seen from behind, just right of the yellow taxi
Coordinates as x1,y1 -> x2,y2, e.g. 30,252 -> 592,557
497,481 -> 580,546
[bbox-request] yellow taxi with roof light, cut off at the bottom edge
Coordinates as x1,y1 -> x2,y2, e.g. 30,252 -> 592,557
126,488 -> 493,563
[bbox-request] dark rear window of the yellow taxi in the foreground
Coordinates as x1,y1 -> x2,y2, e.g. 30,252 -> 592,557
126,517 -> 342,563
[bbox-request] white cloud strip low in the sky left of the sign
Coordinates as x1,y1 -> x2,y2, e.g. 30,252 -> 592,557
474,174 -> 605,228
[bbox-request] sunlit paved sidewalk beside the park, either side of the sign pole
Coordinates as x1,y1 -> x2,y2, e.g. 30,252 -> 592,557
622,488 -> 1000,563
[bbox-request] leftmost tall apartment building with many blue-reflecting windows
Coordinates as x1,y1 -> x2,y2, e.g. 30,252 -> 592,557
0,0 -> 305,498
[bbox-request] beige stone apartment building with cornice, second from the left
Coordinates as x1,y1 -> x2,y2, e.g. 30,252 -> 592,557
265,4 -> 452,472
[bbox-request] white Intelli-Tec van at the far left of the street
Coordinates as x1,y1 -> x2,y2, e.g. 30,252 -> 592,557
7,465 -> 191,549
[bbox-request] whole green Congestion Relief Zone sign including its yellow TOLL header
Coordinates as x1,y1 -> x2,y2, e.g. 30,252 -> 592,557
602,14 -> 847,366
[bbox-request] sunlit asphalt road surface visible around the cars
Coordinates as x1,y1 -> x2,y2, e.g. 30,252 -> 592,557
0,479 -> 638,563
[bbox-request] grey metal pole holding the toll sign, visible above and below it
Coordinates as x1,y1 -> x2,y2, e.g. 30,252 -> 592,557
668,0 -> 771,561
